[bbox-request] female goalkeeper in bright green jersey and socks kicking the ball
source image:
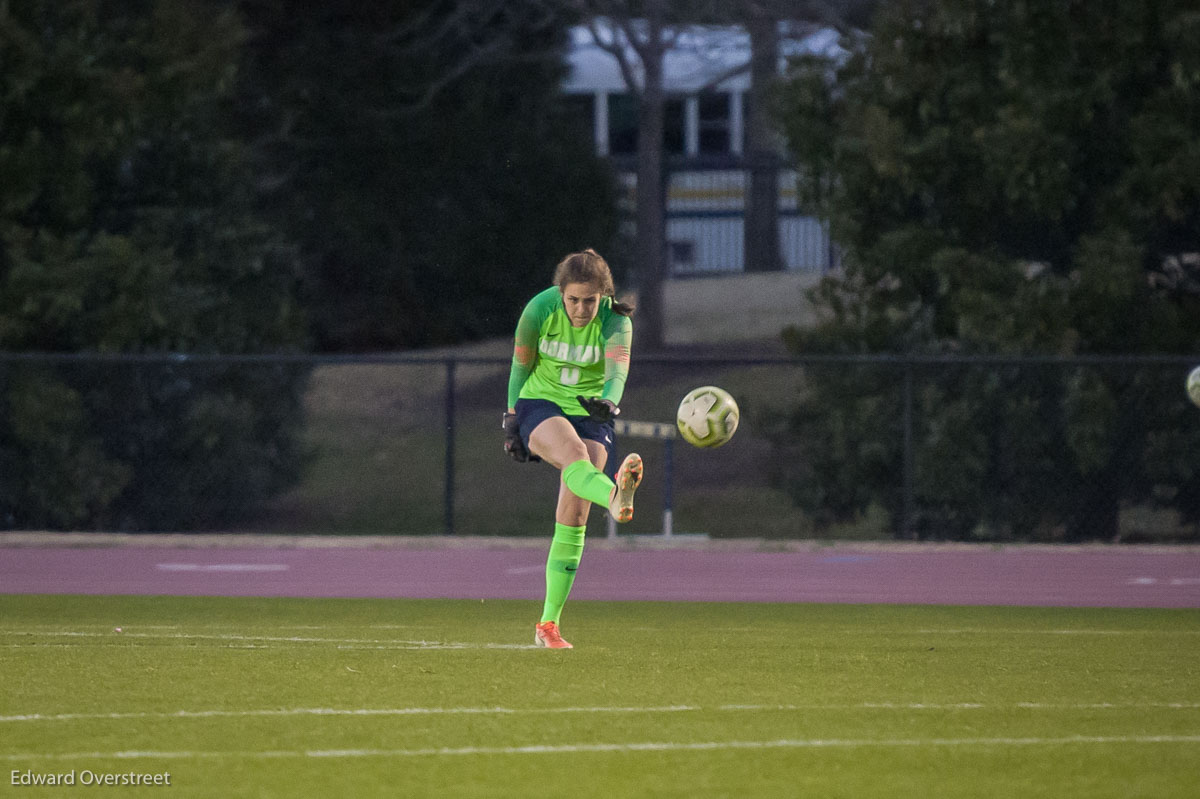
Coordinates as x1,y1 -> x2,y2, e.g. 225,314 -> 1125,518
504,250 -> 642,649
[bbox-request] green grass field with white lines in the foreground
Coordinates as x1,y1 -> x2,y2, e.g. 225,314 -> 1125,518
0,596 -> 1200,799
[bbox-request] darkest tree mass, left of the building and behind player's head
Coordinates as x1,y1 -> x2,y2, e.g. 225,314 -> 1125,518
242,0 -> 620,350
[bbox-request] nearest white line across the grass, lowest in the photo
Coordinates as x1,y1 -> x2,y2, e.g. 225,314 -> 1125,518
0,735 -> 1200,762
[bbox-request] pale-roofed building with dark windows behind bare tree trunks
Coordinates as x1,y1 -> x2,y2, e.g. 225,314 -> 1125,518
564,23 -> 844,277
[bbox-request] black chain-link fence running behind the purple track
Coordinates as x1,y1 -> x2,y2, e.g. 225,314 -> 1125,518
0,354 -> 1200,541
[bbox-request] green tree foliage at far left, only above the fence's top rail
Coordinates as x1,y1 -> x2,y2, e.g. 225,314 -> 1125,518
0,0 -> 304,353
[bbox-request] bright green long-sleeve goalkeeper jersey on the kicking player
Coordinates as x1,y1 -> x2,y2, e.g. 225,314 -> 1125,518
509,286 -> 634,416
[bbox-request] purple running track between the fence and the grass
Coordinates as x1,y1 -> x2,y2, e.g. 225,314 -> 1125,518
0,542 -> 1200,608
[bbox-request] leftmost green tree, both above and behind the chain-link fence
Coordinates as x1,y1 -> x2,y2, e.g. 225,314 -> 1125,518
0,0 -> 305,529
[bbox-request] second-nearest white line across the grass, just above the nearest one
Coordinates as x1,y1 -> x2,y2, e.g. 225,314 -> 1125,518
0,702 -> 1200,723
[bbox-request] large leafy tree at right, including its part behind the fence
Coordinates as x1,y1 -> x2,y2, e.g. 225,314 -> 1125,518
778,0 -> 1200,540
